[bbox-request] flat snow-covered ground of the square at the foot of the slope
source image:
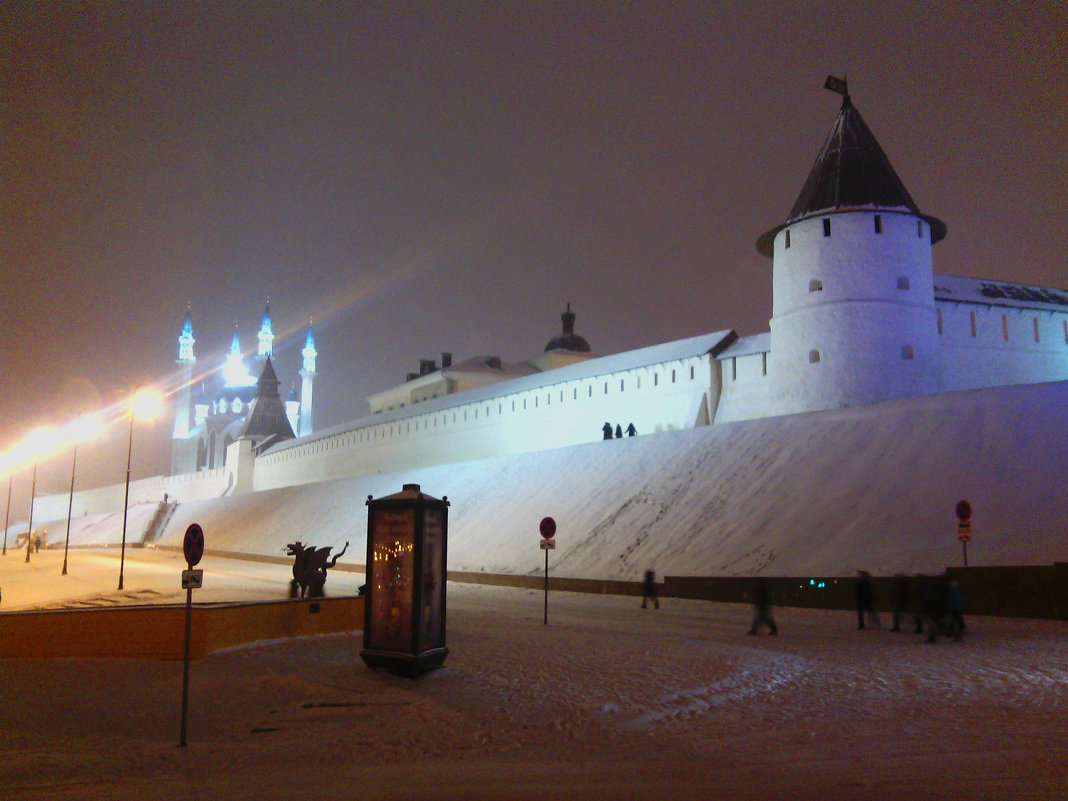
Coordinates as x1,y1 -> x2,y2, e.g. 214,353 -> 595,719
0,550 -> 1068,801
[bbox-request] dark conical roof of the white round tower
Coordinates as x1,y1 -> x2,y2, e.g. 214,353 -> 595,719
756,87 -> 946,256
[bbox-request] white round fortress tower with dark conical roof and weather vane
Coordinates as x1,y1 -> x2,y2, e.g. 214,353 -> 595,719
757,80 -> 946,414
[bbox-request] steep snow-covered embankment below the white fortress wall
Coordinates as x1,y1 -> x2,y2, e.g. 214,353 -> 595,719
43,382 -> 1068,579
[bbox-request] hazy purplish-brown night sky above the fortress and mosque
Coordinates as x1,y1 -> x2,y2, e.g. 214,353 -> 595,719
0,1 -> 1068,508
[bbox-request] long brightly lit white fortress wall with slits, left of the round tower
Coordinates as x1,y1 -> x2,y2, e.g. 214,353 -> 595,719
254,346 -> 723,491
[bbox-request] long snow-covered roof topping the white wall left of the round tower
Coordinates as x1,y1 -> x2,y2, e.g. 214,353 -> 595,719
267,330 -> 738,453
